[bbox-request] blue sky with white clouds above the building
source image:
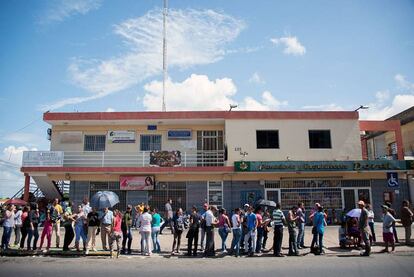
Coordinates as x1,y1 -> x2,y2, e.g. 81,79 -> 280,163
0,0 -> 414,197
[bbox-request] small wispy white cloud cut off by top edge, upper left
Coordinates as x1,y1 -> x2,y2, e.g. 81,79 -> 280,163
39,0 -> 102,24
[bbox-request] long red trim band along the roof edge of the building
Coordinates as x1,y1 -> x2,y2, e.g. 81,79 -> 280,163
43,111 -> 359,121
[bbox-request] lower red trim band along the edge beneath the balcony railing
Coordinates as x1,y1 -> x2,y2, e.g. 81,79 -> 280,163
20,166 -> 234,173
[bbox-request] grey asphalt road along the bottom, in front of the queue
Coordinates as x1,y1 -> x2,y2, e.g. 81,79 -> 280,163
0,253 -> 414,277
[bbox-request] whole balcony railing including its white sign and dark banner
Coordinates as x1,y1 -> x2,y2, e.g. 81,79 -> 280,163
22,151 -> 225,167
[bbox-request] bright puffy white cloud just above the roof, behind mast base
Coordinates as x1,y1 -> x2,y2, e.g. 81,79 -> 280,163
143,74 -> 287,111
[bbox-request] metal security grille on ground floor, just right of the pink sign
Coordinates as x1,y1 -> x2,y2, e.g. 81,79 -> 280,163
148,182 -> 187,214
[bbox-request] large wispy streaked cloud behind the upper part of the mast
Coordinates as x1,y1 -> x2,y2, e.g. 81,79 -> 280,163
42,9 -> 245,110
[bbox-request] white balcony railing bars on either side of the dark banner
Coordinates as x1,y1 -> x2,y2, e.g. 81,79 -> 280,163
22,151 -> 225,167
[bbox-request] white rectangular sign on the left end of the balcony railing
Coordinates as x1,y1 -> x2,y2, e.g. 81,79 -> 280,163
22,151 -> 64,167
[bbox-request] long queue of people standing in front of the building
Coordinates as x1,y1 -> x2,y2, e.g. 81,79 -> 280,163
1,195 -> 413,257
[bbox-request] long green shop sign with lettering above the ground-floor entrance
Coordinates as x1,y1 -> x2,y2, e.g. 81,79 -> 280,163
234,160 -> 414,172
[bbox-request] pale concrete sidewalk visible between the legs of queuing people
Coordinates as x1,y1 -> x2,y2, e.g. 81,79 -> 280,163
0,223 -> 414,256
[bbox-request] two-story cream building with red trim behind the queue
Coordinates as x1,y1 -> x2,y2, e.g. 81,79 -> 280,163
22,111 -> 409,219
